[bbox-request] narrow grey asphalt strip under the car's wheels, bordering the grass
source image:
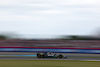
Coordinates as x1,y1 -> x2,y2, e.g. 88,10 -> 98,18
0,57 -> 100,61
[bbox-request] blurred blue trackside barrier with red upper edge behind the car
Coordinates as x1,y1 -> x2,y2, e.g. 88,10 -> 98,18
0,47 -> 100,54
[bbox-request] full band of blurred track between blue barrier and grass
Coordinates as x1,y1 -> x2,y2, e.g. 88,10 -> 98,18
0,52 -> 100,61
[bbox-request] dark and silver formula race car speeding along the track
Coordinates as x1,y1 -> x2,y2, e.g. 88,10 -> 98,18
37,52 -> 67,58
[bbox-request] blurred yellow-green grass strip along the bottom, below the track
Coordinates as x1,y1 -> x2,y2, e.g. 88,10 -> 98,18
0,60 -> 100,67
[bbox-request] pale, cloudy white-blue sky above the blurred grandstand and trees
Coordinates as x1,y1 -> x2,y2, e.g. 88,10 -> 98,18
0,0 -> 100,37
